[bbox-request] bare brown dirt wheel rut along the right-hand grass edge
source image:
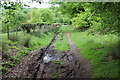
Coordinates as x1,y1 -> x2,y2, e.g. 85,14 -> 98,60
66,32 -> 90,78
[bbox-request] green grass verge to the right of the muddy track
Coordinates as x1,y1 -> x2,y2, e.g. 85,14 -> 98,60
71,32 -> 118,78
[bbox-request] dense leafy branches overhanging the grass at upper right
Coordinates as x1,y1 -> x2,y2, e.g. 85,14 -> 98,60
56,2 -> 120,34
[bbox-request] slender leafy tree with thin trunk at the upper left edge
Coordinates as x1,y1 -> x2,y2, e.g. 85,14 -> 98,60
2,2 -> 22,39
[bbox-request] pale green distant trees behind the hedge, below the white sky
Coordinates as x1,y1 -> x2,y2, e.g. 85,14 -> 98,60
29,6 -> 70,24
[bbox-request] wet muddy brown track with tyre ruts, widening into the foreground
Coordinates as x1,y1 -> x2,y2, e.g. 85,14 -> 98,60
3,33 -> 90,79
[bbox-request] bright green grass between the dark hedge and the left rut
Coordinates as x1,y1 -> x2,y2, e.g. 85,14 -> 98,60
1,32 -> 52,49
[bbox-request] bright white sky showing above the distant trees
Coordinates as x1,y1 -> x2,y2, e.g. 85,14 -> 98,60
11,0 -> 51,8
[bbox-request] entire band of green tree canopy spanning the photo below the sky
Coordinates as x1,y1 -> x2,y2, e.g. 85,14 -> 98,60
2,2 -> 120,34
